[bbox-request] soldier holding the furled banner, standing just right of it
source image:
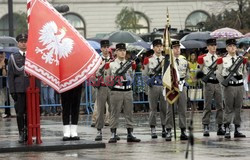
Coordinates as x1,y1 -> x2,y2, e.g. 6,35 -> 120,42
166,41 -> 189,141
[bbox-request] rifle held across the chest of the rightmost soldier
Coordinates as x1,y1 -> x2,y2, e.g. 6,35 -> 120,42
221,47 -> 250,87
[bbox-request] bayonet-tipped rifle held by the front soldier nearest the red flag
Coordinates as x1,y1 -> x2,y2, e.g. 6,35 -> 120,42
108,48 -> 144,89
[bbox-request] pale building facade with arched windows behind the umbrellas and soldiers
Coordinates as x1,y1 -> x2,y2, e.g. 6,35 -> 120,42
0,0 -> 236,38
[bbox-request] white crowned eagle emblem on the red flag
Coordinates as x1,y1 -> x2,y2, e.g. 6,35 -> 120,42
35,21 -> 74,65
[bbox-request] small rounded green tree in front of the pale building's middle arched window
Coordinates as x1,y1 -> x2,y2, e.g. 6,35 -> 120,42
115,7 -> 142,32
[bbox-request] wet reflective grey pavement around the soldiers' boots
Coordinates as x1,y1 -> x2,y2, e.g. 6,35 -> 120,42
0,109 -> 250,160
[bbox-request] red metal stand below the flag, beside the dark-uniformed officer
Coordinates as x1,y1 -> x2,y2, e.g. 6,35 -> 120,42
26,76 -> 42,145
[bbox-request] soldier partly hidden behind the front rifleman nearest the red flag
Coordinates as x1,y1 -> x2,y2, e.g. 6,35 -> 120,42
95,40 -> 113,141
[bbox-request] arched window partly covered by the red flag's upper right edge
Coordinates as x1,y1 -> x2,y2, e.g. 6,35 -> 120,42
63,13 -> 86,37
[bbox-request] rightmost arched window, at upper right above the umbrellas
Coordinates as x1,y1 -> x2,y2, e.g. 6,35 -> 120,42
185,11 -> 210,31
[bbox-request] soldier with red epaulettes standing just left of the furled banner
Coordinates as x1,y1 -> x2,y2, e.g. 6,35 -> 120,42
142,39 -> 167,138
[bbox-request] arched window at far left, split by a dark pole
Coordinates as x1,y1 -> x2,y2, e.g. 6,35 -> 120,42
0,13 -> 27,36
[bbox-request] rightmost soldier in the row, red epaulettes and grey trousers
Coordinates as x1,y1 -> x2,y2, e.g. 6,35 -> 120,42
216,39 -> 247,138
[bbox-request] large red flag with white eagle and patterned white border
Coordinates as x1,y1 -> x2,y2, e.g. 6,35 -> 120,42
25,0 -> 101,93
